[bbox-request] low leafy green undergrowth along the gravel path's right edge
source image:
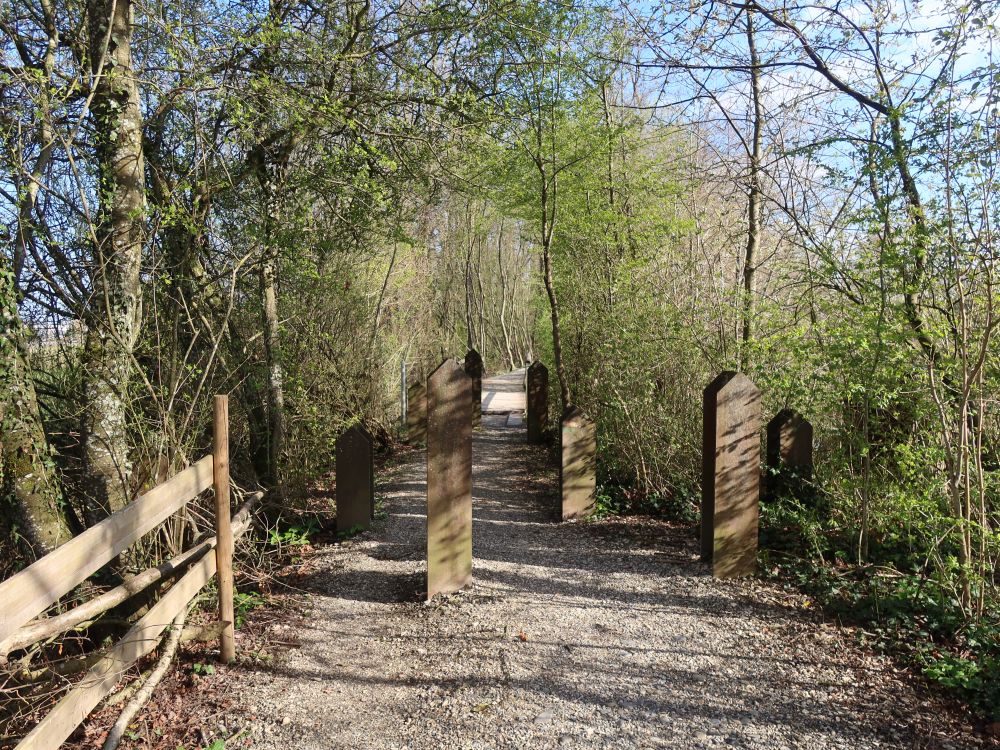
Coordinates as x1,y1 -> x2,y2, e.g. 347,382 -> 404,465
760,498 -> 1000,722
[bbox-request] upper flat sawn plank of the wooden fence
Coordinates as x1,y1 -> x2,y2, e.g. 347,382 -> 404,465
0,455 -> 214,642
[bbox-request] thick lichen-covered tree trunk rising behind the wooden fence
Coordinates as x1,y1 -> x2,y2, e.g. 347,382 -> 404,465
81,0 -> 146,520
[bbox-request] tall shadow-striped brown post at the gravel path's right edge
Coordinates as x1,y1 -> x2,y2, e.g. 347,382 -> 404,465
701,372 -> 761,578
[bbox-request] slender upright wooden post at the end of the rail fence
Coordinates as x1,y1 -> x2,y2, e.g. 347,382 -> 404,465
212,395 -> 236,664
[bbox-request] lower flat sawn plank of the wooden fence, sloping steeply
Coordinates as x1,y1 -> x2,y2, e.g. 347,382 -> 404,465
15,552 -> 215,750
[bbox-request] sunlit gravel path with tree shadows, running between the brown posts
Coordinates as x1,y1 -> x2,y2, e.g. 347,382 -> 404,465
229,406 -> 972,750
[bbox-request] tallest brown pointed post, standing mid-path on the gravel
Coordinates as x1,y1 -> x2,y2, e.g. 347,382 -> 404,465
427,359 -> 472,600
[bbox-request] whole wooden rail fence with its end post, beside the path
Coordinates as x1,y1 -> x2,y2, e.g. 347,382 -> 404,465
0,396 -> 254,750
